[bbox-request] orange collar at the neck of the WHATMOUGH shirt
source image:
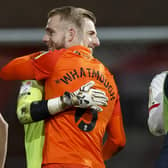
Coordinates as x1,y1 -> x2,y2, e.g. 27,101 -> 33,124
68,46 -> 93,58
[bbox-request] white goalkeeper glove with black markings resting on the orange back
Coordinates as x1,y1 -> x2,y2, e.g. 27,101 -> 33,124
62,81 -> 108,111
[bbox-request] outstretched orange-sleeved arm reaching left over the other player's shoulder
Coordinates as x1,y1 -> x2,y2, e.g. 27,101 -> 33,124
0,50 -> 59,80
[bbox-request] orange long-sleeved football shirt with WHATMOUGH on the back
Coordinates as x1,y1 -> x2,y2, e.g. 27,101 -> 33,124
0,46 -> 126,168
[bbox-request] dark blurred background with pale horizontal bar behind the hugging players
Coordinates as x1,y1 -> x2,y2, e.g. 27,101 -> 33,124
0,0 -> 168,168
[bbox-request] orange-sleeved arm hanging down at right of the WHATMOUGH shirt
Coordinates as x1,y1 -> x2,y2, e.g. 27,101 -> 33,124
102,98 -> 126,160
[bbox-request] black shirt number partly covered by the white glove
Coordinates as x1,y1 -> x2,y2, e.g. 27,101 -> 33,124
75,108 -> 97,132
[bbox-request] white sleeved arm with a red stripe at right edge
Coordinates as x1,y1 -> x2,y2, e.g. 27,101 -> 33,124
148,72 -> 167,136
